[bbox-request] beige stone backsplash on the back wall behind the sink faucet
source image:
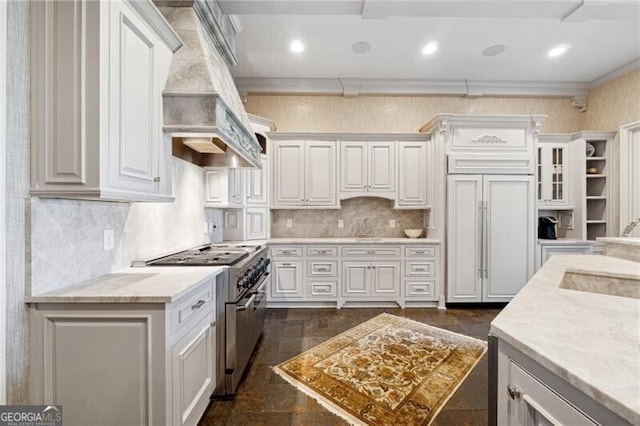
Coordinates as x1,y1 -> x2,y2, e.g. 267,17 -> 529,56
271,197 -> 428,238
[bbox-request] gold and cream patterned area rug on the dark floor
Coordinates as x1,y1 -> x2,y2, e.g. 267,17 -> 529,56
274,314 -> 487,426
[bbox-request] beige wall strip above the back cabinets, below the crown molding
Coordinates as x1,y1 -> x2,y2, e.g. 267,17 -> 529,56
245,95 -> 584,133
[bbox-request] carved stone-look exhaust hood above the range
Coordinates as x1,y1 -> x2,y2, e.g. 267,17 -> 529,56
155,0 -> 261,168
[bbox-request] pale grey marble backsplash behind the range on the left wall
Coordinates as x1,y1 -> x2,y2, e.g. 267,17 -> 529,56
30,157 -> 222,294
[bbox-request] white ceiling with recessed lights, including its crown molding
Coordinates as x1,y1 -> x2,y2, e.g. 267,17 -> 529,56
218,0 -> 640,96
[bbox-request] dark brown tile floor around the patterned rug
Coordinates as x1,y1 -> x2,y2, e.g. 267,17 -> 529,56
200,308 -> 500,426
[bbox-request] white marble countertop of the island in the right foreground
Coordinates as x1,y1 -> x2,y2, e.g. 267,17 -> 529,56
490,255 -> 640,424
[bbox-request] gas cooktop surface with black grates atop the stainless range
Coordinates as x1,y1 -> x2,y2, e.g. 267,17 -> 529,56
146,244 -> 260,266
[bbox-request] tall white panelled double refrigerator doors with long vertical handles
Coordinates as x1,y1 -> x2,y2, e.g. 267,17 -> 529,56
447,175 -> 535,302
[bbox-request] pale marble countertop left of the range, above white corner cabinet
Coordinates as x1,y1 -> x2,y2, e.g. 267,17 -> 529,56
25,266 -> 226,303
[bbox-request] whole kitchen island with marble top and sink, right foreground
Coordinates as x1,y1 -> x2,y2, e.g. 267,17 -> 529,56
490,255 -> 640,425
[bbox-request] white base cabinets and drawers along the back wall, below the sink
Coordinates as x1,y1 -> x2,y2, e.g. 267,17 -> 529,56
267,238 -> 444,308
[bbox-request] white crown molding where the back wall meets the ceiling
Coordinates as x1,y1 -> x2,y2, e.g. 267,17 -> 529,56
235,78 -> 591,97
